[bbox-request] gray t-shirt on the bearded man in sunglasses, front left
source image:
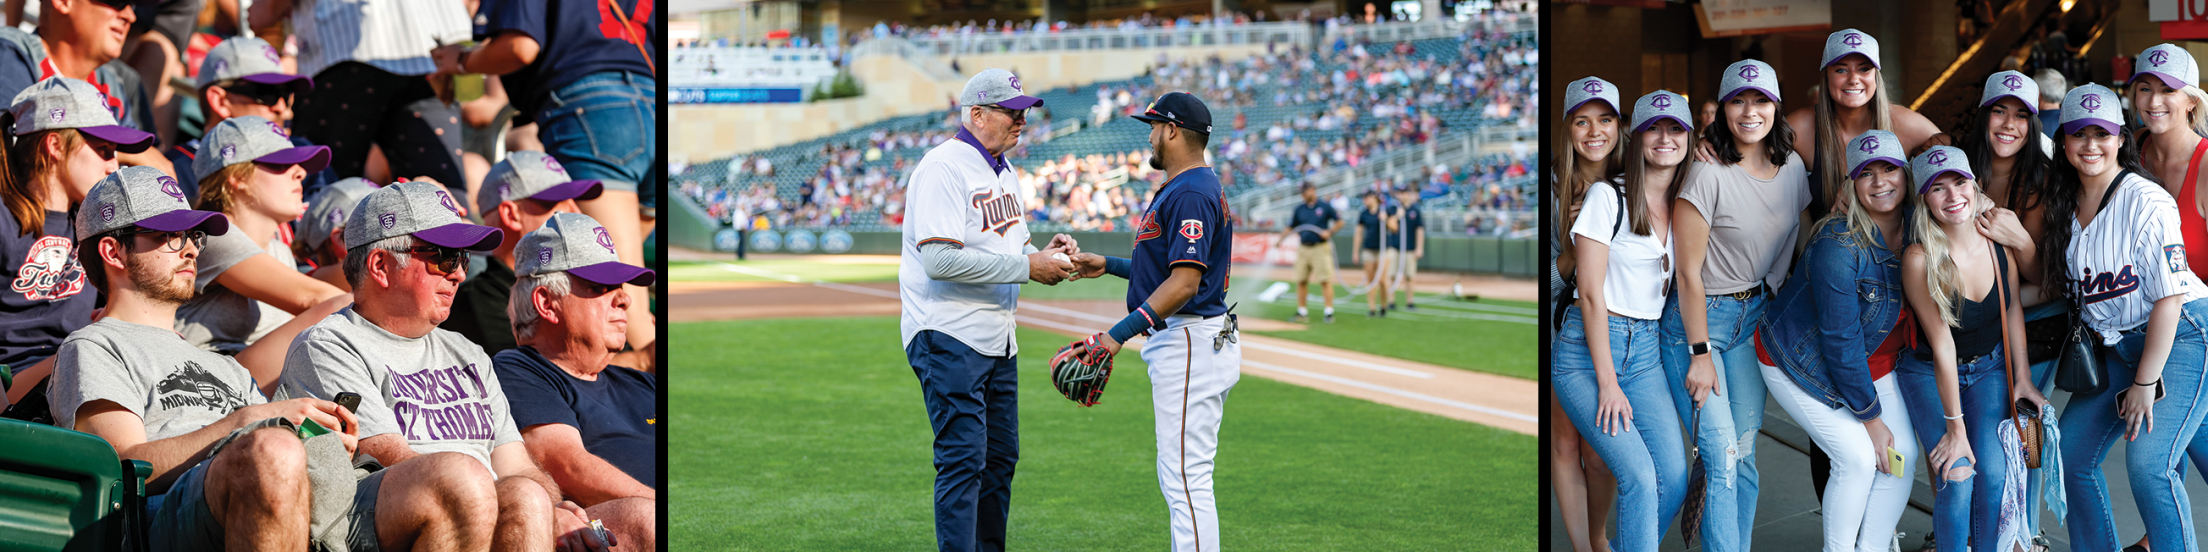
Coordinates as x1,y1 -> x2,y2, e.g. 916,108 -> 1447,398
46,318 -> 267,442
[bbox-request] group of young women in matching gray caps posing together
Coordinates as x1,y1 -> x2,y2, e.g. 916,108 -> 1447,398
1550,29 -> 2208,552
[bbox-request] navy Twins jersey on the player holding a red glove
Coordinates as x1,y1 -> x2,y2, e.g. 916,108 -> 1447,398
1126,168 -> 1234,316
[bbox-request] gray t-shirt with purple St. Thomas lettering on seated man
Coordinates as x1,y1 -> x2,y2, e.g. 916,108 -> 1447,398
283,307 -> 521,473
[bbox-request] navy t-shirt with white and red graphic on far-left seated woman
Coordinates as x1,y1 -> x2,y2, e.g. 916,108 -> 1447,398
0,205 -> 99,371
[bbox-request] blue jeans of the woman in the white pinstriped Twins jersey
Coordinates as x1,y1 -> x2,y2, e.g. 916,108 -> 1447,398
2062,300 -> 2208,552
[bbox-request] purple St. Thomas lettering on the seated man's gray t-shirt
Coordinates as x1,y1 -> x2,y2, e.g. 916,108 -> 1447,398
384,362 -> 497,442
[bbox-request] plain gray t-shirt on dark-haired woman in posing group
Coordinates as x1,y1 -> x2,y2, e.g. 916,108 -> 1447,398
1678,155 -> 1811,296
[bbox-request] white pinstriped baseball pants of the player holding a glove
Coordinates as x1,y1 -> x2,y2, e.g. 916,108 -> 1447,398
1142,316 -> 1241,552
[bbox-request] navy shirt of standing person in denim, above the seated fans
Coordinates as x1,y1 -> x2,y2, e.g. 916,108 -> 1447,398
481,0 -> 665,115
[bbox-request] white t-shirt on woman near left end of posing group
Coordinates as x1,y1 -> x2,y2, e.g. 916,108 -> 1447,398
1572,181 -> 1671,320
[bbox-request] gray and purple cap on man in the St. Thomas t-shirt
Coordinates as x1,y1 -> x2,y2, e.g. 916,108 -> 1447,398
344,181 -> 506,252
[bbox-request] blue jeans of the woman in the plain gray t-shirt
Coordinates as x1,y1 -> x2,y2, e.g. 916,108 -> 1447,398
1660,294 -> 1771,552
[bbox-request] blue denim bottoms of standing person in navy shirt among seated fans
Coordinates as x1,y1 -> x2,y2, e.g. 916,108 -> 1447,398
537,71 -> 658,192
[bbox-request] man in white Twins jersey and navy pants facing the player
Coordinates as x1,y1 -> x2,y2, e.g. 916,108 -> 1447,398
896,68 -> 1080,552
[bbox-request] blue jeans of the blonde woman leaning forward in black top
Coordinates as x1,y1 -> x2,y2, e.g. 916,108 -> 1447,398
1894,347 -> 2025,550
